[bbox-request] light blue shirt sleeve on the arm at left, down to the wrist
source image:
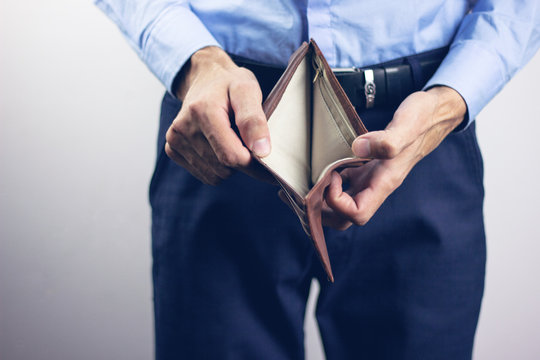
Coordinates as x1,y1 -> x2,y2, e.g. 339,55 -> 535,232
95,0 -> 219,92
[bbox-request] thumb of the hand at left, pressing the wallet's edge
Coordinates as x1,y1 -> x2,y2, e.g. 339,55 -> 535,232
229,69 -> 271,157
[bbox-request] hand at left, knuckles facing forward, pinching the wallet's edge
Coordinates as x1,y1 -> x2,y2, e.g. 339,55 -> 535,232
165,47 -> 270,185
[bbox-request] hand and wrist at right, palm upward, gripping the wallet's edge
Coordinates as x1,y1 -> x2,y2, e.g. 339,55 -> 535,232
323,86 -> 467,230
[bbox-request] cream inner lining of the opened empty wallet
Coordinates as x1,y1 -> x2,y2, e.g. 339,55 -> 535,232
261,53 -> 356,197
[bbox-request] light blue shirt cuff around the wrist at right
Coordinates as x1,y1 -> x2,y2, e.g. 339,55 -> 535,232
424,40 -> 506,131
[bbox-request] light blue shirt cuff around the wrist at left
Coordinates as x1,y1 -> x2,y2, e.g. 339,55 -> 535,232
141,5 -> 220,95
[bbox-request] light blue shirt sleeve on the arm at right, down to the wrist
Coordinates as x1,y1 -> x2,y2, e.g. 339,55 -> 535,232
425,0 -> 540,131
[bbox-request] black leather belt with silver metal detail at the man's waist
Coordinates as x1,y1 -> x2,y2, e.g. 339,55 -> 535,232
231,47 -> 448,111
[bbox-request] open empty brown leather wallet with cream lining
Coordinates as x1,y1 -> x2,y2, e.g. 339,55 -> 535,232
255,40 -> 368,282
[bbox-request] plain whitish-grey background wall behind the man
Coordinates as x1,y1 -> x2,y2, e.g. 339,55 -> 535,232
0,0 -> 540,360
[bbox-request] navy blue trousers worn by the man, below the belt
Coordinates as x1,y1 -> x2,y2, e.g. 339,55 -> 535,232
150,91 -> 485,360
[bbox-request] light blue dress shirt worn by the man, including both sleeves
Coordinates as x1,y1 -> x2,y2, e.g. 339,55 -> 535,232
95,0 -> 540,122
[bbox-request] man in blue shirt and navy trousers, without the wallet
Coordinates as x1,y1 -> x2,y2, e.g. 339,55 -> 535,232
96,0 -> 540,359
